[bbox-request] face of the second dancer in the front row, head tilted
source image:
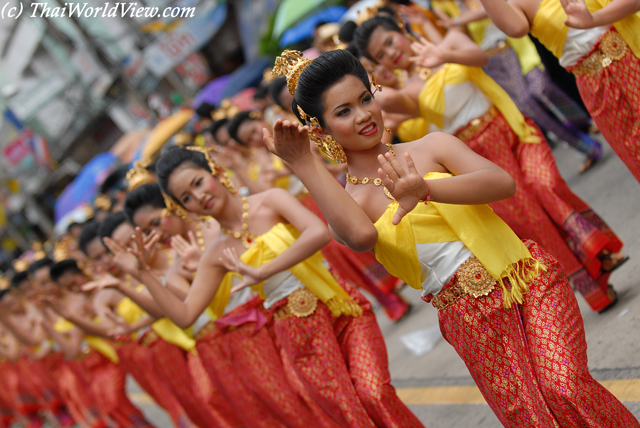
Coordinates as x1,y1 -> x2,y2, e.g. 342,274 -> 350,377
168,163 -> 230,218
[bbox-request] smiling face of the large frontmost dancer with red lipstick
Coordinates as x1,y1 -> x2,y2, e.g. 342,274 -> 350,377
322,75 -> 384,151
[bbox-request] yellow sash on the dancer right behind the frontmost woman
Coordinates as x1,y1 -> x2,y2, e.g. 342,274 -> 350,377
416,64 -> 540,143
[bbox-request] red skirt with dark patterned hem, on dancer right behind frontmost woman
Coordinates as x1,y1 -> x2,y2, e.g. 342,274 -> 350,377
458,113 -> 622,311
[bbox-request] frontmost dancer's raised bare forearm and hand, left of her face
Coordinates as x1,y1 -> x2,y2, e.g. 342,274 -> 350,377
264,120 -> 378,252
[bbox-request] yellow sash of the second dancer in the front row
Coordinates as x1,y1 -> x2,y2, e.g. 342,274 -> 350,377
218,223 -> 362,317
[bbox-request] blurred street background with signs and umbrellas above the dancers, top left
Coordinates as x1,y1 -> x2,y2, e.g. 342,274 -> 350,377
0,0 -> 368,271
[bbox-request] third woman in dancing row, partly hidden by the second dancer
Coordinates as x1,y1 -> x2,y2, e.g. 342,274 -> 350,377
117,175 -> 320,428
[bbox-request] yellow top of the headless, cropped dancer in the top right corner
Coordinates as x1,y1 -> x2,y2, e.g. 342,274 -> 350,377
531,0 -> 640,58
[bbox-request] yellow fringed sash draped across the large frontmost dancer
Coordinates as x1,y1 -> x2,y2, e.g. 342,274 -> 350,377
374,172 -> 544,307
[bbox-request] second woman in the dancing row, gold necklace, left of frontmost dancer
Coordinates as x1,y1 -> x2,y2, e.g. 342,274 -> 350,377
138,145 -> 422,427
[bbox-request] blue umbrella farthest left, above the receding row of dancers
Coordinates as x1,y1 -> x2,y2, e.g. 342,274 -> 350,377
54,152 -> 116,222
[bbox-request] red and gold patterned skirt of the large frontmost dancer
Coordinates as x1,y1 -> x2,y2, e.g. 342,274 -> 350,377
438,241 -> 640,428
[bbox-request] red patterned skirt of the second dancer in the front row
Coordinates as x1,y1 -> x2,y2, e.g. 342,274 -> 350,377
269,282 -> 423,428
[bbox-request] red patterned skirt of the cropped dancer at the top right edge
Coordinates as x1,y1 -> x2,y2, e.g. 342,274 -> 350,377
567,27 -> 640,181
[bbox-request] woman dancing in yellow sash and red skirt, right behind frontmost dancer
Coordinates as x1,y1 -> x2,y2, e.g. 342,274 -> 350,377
356,17 -> 626,311
